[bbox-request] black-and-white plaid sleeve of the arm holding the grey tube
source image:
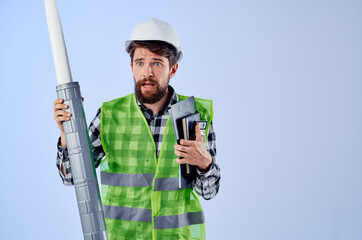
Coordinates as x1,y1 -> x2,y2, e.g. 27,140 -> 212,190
56,108 -> 105,186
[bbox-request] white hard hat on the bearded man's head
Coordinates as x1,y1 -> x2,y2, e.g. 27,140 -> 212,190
126,18 -> 183,62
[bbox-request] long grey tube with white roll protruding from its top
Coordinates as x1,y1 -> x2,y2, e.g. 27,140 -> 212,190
44,0 -> 108,240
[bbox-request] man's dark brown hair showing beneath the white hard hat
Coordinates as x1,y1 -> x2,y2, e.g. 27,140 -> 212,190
126,41 -> 180,68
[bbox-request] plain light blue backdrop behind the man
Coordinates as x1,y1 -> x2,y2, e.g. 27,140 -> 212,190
0,0 -> 362,240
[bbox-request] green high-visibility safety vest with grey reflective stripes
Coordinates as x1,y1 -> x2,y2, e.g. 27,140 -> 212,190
101,94 -> 213,240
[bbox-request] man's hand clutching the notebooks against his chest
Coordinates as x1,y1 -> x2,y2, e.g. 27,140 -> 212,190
174,123 -> 212,171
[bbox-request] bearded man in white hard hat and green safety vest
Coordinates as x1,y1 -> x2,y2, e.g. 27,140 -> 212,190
54,18 -> 220,240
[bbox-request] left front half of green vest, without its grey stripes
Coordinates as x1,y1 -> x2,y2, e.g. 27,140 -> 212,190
101,95 -> 157,239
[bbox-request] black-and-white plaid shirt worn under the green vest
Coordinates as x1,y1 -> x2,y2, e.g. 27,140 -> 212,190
57,86 -> 220,200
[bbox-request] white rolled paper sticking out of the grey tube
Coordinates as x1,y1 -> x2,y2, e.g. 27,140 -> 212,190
44,0 -> 73,85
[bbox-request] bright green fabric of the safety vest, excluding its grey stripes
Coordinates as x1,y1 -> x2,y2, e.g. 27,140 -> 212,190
101,94 -> 213,240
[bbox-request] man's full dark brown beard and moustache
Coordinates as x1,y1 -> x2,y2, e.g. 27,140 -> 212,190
135,78 -> 170,104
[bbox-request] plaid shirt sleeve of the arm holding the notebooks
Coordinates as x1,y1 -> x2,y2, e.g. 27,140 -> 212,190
193,121 -> 221,200
